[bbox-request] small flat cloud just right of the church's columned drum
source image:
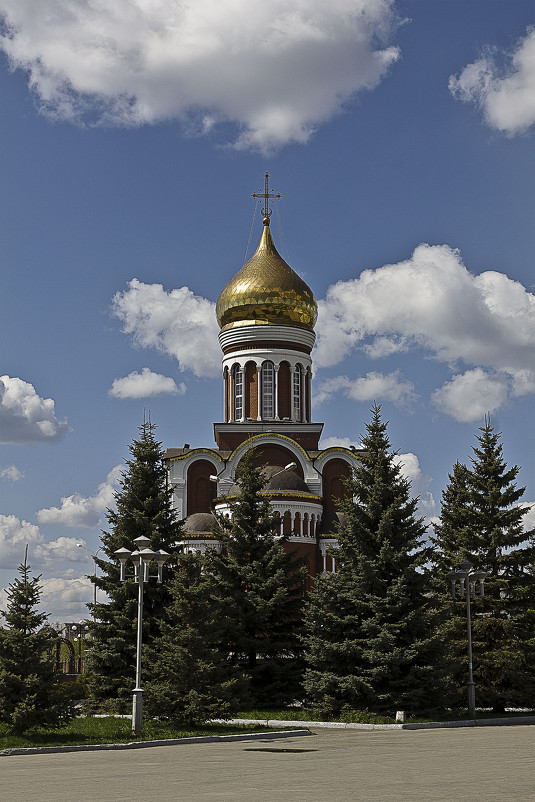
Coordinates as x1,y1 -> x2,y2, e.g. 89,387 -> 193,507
314,370 -> 416,407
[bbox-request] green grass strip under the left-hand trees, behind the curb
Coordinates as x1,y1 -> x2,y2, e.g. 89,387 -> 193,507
0,716 -> 274,749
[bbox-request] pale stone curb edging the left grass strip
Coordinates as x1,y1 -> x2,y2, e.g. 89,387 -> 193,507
0,722 -> 312,757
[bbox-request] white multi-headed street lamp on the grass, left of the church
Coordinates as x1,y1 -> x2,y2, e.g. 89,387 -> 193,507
115,535 -> 169,732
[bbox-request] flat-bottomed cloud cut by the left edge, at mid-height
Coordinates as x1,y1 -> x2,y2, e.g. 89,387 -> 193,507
0,376 -> 70,444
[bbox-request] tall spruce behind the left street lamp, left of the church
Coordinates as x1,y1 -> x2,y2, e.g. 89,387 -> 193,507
88,421 -> 181,709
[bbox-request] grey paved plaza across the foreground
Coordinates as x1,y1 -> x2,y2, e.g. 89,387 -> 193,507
0,726 -> 535,802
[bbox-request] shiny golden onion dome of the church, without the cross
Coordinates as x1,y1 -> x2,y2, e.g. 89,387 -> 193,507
216,217 -> 318,330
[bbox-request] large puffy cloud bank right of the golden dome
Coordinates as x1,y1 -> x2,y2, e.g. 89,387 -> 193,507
315,244 -> 535,420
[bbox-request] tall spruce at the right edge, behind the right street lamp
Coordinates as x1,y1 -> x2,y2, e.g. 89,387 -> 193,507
434,418 -> 535,712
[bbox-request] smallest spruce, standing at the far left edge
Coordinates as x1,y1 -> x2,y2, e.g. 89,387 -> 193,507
0,547 -> 73,735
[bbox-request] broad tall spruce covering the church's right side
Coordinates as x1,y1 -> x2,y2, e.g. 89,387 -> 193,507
304,404 -> 446,716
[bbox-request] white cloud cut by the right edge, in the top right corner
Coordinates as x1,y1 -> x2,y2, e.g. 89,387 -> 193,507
449,28 -> 535,136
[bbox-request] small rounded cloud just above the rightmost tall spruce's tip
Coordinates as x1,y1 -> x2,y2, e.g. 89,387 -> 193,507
432,368 -> 508,423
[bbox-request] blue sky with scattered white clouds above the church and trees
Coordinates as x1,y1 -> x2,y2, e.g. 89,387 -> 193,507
0,0 -> 535,623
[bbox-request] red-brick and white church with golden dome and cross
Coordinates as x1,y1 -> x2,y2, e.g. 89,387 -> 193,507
165,173 -> 358,576
